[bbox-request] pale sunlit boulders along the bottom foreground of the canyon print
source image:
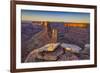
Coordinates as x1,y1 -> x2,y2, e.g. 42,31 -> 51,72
25,43 -> 90,62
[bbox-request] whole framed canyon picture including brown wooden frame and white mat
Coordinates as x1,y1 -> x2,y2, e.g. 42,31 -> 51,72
11,1 -> 97,73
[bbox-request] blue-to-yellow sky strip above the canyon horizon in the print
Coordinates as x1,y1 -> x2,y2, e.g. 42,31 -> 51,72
21,10 -> 90,23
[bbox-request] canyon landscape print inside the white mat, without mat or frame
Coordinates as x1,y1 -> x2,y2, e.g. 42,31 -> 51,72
21,10 -> 90,62
